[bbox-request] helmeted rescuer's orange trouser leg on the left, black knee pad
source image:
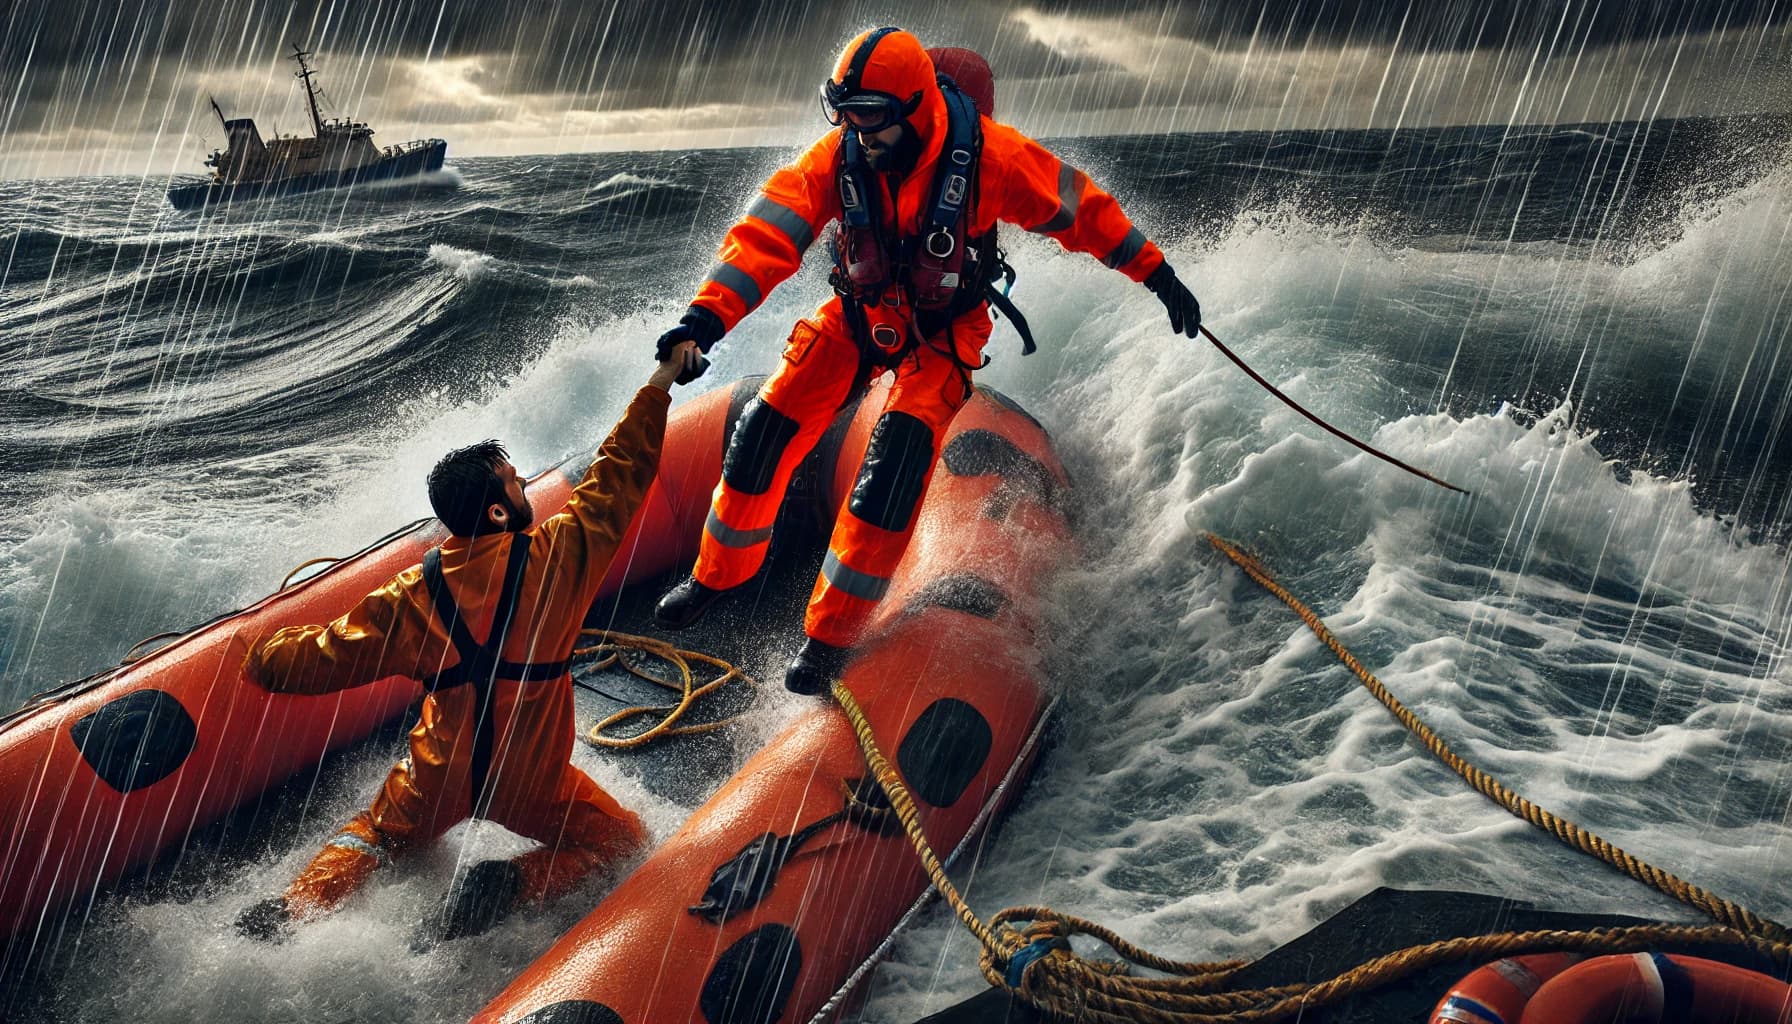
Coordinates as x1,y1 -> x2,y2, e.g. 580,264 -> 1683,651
692,308 -> 860,590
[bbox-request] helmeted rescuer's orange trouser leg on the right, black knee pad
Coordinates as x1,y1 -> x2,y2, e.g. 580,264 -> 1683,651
803,303 -> 989,647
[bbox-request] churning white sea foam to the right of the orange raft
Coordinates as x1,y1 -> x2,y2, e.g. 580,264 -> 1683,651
849,188 -> 1792,1020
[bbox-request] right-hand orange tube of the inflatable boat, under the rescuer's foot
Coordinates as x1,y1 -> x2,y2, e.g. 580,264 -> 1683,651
475,380 -> 1070,1024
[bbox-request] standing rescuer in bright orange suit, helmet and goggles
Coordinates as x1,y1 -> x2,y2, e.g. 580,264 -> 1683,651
656,29 -> 1201,694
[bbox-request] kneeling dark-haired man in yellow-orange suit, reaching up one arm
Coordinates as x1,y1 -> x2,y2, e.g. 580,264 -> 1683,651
237,344 -> 697,938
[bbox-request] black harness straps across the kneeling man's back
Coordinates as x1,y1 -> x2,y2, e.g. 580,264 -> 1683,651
423,533 -> 568,818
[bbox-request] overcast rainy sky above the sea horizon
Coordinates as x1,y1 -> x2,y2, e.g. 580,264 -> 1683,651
0,0 -> 1792,178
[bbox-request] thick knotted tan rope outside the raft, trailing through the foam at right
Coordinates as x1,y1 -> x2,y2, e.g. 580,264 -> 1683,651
833,534 -> 1792,1024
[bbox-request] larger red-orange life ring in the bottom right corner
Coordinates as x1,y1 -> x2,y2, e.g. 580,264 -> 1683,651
1521,952 -> 1792,1024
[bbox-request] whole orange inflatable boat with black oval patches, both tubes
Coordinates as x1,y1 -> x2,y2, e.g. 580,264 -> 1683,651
0,380 -> 1072,1024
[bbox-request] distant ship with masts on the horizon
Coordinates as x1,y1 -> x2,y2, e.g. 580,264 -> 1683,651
168,45 -> 448,210
